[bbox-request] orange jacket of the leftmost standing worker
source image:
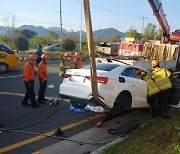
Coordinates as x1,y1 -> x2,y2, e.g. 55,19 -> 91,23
23,62 -> 34,82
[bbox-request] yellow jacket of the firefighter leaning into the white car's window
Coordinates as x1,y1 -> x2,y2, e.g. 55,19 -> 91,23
143,76 -> 160,97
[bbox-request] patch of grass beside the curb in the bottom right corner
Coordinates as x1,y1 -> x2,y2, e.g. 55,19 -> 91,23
100,109 -> 180,154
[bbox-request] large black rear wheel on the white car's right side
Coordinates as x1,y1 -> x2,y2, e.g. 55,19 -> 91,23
112,91 -> 132,113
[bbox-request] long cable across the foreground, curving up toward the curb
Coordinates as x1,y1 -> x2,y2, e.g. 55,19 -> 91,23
0,128 -> 124,145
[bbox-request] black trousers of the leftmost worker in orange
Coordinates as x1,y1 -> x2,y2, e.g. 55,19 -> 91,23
22,80 -> 36,105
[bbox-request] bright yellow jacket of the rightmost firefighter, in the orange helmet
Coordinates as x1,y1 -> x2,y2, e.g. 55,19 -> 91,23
153,67 -> 172,91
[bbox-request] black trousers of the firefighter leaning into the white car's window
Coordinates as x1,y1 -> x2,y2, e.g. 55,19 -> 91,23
147,93 -> 159,116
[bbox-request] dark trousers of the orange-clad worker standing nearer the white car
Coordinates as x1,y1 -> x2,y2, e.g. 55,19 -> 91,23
38,79 -> 47,102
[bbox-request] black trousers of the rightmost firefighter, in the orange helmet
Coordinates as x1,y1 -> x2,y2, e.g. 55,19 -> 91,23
158,89 -> 171,114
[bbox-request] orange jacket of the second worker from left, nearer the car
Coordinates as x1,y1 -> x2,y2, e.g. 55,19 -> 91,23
38,60 -> 48,80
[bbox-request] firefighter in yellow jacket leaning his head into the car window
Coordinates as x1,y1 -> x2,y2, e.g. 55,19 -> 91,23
140,72 -> 160,117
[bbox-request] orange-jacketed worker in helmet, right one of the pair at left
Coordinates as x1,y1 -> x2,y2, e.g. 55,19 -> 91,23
38,54 -> 48,104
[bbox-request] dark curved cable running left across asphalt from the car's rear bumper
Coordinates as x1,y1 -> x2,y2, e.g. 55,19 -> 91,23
3,105 -> 69,130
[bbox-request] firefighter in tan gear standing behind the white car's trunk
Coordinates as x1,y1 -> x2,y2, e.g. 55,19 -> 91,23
59,52 -> 74,76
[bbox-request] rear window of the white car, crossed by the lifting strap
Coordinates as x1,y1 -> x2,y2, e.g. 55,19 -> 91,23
84,63 -> 119,72
